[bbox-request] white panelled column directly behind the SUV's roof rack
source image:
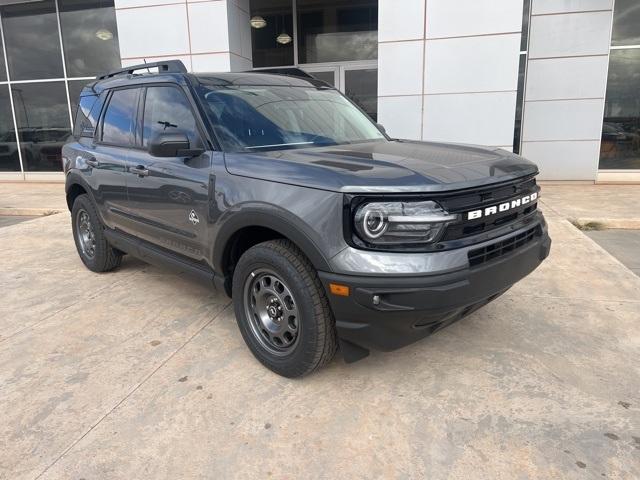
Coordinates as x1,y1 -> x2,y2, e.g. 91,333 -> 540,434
115,0 -> 252,72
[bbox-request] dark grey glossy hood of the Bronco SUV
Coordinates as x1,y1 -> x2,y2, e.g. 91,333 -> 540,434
225,140 -> 538,193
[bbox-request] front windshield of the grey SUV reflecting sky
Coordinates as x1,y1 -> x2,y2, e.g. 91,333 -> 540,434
199,86 -> 385,152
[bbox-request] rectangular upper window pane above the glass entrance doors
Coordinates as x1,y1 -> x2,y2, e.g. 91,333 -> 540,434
297,0 -> 378,63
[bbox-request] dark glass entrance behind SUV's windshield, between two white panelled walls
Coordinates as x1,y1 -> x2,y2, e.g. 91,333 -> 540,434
251,0 -> 378,121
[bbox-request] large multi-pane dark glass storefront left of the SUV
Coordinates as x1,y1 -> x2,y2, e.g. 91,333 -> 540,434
0,0 -> 120,172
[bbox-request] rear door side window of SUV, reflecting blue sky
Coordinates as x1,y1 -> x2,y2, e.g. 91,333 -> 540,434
102,88 -> 138,146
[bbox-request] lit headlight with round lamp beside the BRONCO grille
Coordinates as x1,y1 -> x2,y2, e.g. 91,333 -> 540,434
353,201 -> 458,245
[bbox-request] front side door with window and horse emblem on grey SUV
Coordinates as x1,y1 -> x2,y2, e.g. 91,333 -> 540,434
119,84 -> 211,260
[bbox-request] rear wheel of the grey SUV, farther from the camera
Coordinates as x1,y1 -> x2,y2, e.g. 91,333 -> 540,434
71,194 -> 122,272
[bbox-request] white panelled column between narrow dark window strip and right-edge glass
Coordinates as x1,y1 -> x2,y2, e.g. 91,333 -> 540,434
522,0 -> 613,180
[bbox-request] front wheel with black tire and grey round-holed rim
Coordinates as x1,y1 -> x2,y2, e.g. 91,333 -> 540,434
232,240 -> 337,378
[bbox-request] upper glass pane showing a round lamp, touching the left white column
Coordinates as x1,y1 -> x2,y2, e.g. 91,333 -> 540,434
59,0 -> 120,77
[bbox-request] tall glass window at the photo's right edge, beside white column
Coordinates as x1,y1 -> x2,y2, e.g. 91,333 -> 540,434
600,0 -> 640,170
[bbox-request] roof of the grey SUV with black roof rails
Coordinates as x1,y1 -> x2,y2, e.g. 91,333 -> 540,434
81,60 -> 332,94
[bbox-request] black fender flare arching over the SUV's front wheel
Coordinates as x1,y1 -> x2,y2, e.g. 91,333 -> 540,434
213,208 -> 331,273
